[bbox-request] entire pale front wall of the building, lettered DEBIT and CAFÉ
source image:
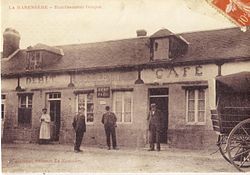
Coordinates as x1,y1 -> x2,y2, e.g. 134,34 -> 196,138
2,62 -> 250,149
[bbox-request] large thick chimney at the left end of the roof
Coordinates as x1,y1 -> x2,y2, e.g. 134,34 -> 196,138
3,28 -> 20,58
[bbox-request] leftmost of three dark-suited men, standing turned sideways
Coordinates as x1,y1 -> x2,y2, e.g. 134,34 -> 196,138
72,108 -> 86,152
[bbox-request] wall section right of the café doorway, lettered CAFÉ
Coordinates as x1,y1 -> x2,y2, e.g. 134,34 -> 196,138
142,64 -> 218,149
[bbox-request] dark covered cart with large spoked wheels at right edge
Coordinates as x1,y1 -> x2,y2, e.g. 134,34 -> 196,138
211,72 -> 250,171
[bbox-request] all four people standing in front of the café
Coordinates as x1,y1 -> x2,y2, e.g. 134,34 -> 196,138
39,103 -> 163,153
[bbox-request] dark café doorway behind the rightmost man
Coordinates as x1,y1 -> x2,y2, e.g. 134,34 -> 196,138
149,88 -> 168,143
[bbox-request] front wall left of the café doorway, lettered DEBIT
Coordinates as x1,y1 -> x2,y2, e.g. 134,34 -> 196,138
1,72 -> 148,146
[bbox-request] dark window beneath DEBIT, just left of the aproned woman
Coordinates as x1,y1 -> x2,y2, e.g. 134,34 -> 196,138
18,94 -> 32,126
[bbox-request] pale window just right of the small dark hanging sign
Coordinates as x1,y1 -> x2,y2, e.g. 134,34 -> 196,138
113,91 -> 133,123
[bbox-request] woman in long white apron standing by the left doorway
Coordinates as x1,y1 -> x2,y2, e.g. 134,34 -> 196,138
39,108 -> 50,144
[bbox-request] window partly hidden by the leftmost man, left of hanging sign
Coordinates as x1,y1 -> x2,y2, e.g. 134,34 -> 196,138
77,93 -> 94,124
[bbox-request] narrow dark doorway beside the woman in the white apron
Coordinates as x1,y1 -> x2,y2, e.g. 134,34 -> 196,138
48,93 -> 61,141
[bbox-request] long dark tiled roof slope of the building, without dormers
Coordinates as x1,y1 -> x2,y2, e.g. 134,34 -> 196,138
1,28 -> 250,75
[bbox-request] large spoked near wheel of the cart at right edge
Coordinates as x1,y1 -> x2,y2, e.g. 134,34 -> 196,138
227,119 -> 250,171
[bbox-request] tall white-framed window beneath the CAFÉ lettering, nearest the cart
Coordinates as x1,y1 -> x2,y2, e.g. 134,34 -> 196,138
186,89 -> 206,124
